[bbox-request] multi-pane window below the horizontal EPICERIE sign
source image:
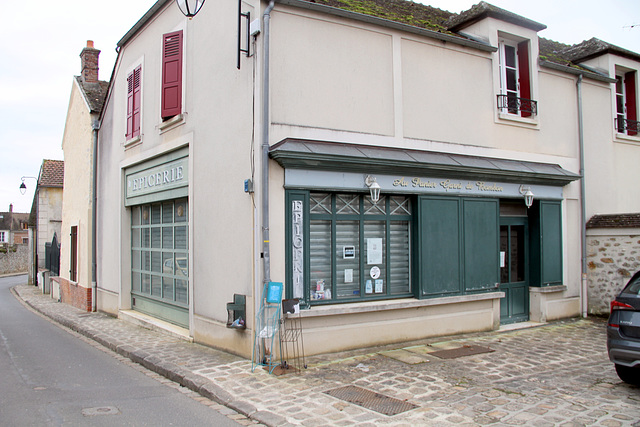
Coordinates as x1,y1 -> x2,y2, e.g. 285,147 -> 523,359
131,199 -> 189,306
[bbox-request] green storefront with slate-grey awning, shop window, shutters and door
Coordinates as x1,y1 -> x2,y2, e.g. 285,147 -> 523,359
271,140 -> 577,323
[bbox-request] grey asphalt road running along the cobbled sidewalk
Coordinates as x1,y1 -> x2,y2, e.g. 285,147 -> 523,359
0,276 -> 239,426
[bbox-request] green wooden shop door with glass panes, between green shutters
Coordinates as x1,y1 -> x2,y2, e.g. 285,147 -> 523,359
500,217 -> 529,324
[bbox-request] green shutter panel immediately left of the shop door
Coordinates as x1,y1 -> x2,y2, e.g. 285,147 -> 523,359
463,199 -> 500,292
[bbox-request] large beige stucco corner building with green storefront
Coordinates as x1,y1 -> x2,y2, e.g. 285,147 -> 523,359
92,0 -> 640,357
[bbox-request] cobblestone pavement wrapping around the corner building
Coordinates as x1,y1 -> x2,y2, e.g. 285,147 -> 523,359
14,285 -> 640,427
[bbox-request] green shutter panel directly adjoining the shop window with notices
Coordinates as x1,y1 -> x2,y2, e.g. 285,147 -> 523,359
419,197 -> 462,297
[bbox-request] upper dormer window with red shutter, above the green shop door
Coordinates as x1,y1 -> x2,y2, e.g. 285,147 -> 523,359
498,39 -> 538,117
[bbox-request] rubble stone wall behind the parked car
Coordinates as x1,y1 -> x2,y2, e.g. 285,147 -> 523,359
587,229 -> 640,314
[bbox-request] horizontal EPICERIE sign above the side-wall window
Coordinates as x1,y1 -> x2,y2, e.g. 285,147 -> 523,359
127,157 -> 189,197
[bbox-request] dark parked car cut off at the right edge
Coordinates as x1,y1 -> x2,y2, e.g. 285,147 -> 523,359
607,271 -> 640,385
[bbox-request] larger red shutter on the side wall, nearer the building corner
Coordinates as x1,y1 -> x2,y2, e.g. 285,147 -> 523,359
161,31 -> 182,120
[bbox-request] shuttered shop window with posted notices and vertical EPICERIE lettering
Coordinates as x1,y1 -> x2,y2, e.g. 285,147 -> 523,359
287,192 -> 412,304
